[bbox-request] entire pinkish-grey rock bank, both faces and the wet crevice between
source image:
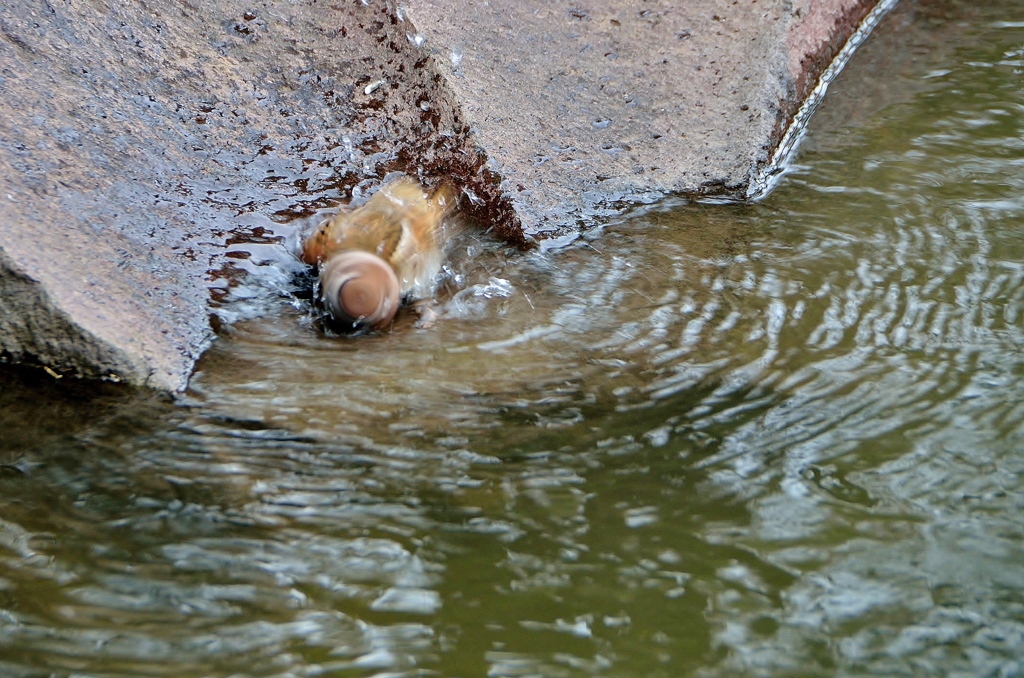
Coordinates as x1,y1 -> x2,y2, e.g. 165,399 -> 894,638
0,0 -> 873,390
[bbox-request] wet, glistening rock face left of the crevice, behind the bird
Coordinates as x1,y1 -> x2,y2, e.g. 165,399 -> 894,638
0,0 -> 499,389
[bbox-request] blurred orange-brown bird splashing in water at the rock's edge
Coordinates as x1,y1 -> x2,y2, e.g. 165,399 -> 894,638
302,177 -> 455,329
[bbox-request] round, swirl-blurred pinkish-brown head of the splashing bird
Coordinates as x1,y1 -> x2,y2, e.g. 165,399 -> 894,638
321,250 -> 399,329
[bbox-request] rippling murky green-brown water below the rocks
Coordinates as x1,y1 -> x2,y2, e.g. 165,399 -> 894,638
0,0 -> 1024,678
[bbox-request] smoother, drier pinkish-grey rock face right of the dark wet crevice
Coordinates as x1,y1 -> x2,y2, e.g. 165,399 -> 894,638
408,0 -> 877,235
